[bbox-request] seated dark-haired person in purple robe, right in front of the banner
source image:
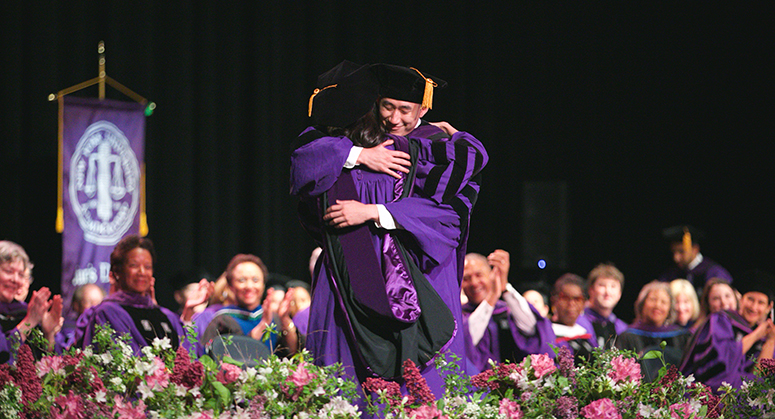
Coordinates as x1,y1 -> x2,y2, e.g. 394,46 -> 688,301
76,235 -> 188,354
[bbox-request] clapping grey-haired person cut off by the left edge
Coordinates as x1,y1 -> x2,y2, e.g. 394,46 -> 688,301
0,240 -> 63,362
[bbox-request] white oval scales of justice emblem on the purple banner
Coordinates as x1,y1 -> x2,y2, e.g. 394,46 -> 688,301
68,121 -> 140,246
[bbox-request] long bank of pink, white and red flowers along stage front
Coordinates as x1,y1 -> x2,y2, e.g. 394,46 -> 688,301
0,327 -> 775,419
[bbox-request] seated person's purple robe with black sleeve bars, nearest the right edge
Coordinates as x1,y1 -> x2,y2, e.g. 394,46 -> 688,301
681,310 -> 764,391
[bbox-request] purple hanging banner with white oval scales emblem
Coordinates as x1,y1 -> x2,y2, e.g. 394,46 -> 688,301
62,97 -> 145,322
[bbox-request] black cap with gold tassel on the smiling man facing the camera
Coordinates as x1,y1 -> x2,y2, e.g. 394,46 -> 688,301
371,64 -> 447,109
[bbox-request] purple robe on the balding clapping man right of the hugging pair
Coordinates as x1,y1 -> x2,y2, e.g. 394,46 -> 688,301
463,300 -> 556,373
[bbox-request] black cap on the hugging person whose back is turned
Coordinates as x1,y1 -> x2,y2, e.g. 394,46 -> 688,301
309,60 -> 379,127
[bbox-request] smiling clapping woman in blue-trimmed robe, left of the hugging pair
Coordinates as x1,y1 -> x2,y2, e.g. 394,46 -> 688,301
202,254 -> 299,355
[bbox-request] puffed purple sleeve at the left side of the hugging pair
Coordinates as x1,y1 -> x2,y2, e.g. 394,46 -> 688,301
291,128 -> 353,197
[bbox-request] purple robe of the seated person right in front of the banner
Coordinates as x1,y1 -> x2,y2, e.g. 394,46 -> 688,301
78,291 -> 191,355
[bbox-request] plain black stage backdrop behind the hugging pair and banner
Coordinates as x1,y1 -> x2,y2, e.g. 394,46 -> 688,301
0,0 -> 775,319
